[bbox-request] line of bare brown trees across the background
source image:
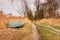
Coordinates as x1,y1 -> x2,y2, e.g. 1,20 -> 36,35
16,0 -> 59,20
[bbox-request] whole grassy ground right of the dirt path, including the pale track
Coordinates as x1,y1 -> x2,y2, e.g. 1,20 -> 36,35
34,18 -> 60,40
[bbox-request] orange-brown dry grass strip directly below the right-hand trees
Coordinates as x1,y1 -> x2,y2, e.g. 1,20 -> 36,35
40,18 -> 60,25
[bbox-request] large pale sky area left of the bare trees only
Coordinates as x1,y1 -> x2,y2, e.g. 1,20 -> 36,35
0,0 -> 23,16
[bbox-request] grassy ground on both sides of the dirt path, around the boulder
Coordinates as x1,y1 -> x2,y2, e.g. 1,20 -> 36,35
0,17 -> 60,40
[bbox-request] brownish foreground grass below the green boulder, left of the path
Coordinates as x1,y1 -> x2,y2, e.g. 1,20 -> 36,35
0,24 -> 31,40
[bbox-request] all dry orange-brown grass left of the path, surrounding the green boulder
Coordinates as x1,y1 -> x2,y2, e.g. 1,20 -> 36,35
0,16 -> 31,40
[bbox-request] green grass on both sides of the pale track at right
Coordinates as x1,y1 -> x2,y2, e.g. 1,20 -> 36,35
34,21 -> 60,40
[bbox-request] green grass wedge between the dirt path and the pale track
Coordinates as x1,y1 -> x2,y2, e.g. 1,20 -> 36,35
38,27 -> 60,40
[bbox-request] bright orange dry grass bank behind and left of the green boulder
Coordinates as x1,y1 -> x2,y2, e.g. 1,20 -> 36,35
0,17 -> 30,29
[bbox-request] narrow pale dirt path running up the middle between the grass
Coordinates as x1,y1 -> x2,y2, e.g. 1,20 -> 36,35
31,23 -> 40,40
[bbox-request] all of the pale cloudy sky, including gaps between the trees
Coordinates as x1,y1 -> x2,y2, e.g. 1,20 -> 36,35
0,0 -> 60,16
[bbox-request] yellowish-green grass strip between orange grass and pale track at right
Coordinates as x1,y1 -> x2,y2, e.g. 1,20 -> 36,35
34,20 -> 60,30
